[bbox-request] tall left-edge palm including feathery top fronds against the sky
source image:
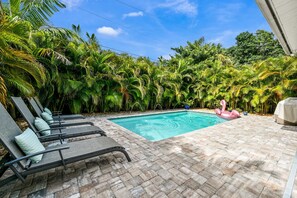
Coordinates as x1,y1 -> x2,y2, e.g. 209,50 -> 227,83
0,0 -> 65,104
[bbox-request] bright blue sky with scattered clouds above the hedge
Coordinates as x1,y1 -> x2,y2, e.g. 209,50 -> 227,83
50,0 -> 271,61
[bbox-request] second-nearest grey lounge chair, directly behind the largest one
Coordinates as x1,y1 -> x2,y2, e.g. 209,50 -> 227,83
9,97 -> 106,142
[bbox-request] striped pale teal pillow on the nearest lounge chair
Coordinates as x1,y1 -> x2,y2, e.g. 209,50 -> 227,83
15,128 -> 45,163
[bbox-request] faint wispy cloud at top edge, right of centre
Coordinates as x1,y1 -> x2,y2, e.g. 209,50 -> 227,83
158,0 -> 198,16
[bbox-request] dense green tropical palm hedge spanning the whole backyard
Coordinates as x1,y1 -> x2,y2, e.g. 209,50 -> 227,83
0,0 -> 297,113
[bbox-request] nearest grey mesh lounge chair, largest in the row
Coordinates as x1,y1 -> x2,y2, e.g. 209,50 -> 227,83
0,103 -> 131,186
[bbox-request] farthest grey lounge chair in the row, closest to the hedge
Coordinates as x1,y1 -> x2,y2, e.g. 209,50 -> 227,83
33,96 -> 86,120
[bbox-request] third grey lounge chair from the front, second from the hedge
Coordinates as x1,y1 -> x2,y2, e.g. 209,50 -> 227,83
11,97 -> 94,127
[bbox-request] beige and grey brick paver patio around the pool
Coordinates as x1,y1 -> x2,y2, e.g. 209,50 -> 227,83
0,110 -> 297,198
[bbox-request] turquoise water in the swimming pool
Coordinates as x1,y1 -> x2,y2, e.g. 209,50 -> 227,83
110,111 -> 226,141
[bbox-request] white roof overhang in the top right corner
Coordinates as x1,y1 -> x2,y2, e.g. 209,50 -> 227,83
256,0 -> 297,55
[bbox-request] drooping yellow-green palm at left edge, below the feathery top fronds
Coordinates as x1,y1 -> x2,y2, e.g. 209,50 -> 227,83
0,5 -> 45,104
